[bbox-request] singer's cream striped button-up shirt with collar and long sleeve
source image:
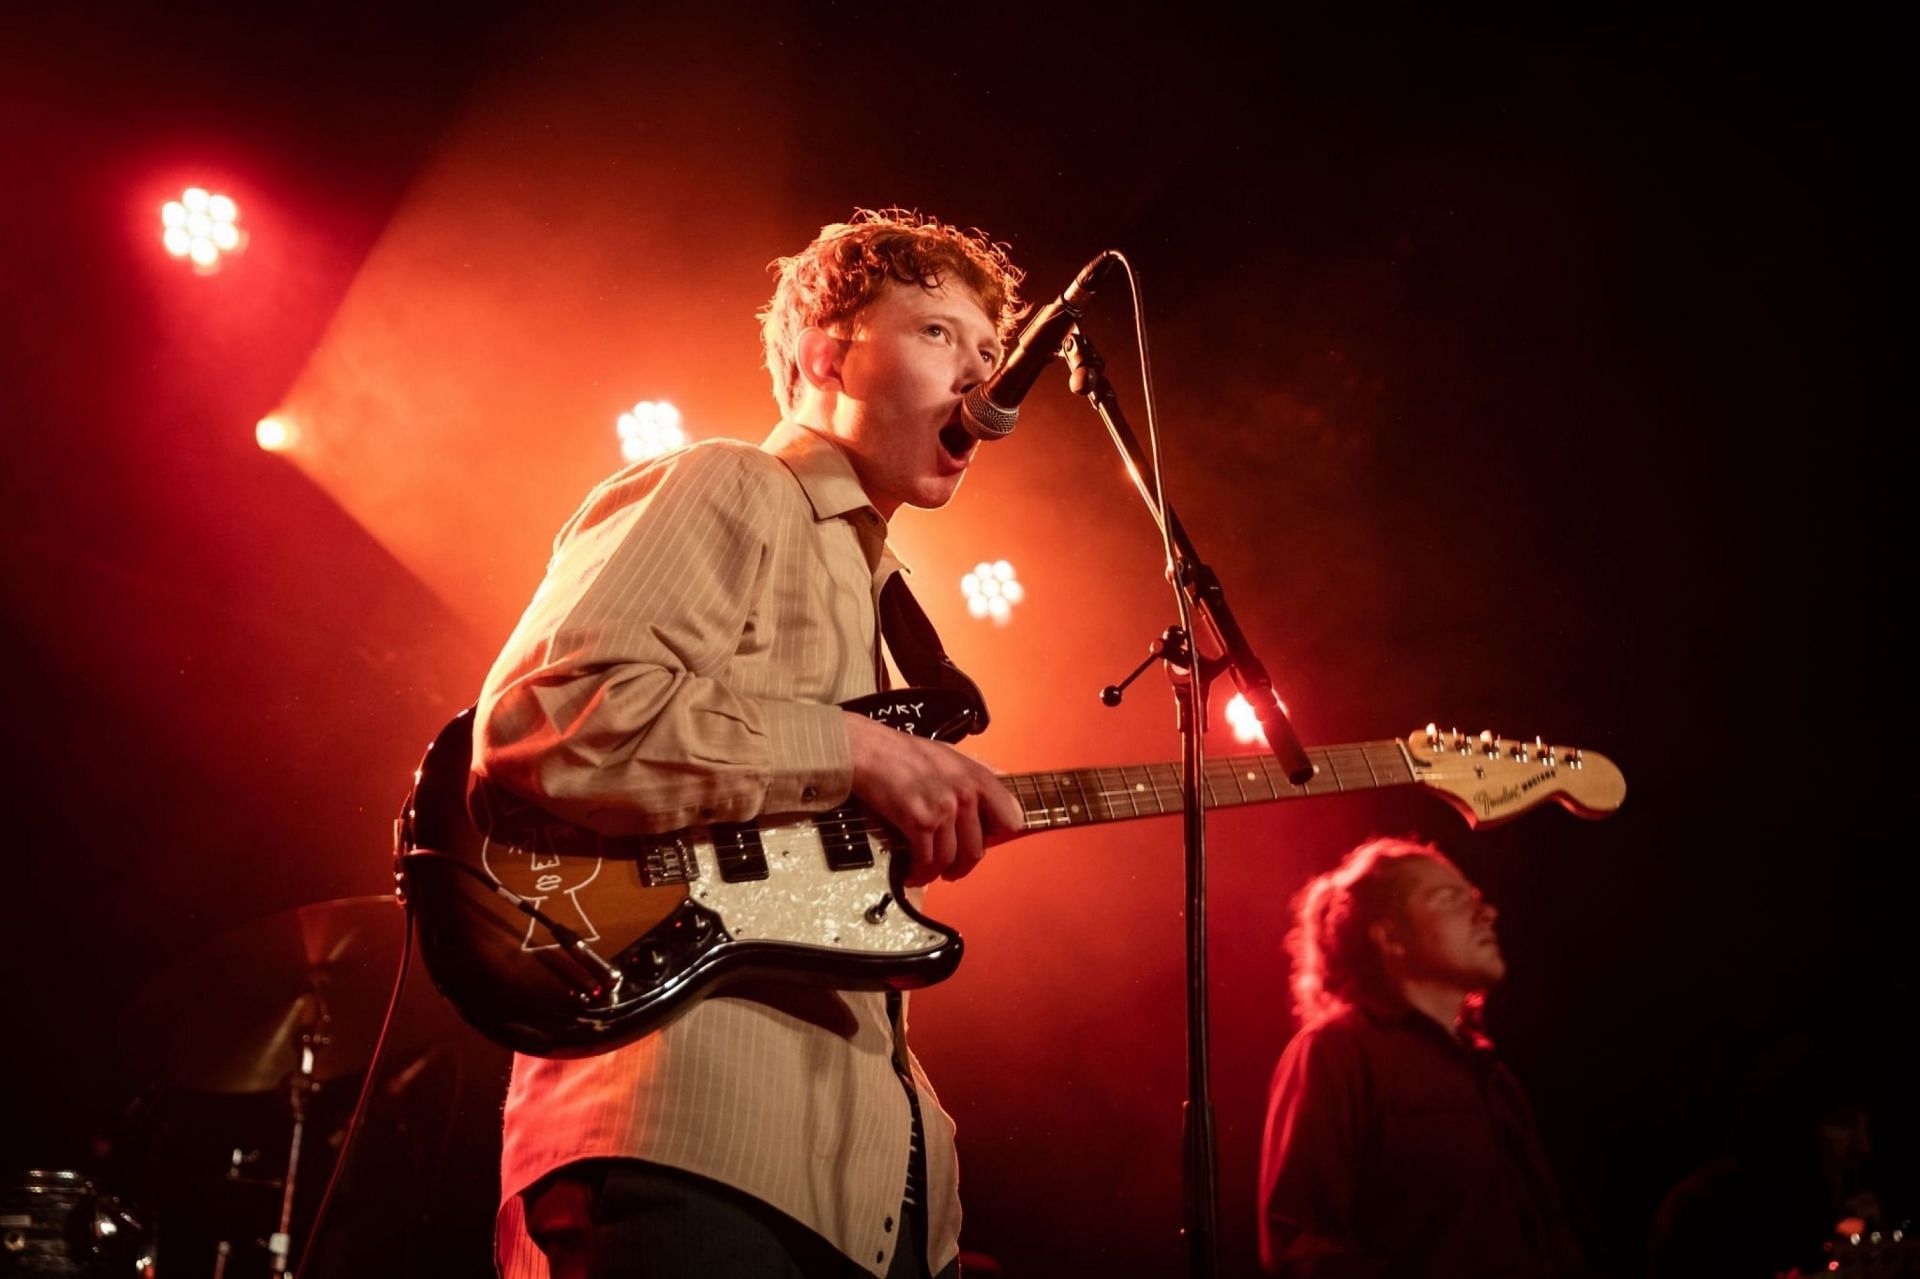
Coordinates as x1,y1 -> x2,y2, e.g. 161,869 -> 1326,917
474,422 -> 960,1279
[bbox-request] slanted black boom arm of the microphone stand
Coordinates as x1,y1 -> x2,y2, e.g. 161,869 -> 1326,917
1066,328 -> 1313,785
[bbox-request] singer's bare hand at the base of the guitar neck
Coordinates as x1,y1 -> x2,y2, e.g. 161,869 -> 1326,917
845,711 -> 1025,885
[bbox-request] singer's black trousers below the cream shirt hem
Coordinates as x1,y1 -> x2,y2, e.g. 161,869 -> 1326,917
522,1160 -> 960,1279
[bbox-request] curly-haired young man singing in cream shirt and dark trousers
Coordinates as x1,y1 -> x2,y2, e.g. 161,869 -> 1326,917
474,209 -> 1021,1279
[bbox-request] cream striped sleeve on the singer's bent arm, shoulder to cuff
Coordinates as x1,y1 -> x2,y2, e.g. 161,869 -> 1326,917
474,444 -> 852,833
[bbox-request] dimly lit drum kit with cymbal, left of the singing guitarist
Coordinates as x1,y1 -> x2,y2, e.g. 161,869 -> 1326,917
0,897 -> 497,1279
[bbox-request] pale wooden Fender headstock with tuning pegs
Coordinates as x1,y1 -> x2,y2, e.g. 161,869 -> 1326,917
1404,724 -> 1626,826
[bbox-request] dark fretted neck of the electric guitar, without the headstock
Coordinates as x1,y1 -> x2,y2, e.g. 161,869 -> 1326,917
1000,741 -> 1415,832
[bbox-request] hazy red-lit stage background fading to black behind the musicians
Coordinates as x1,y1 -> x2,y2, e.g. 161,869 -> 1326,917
0,6 -> 1920,1275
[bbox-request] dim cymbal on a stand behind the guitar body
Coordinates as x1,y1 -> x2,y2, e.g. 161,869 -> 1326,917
121,897 -> 411,1093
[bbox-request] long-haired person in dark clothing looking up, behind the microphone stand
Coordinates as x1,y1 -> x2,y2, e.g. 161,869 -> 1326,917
1260,839 -> 1580,1279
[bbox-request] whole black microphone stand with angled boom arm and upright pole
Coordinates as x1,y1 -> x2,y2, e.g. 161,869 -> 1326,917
1062,326 -> 1313,1279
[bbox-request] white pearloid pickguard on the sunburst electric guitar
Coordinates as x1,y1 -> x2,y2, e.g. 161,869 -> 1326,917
685,818 -> 945,954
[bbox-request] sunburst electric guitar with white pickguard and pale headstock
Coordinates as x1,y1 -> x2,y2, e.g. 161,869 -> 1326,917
396,689 -> 1626,1056
